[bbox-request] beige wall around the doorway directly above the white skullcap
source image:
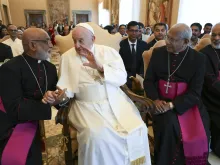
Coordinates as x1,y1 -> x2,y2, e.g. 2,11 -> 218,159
70,0 -> 98,24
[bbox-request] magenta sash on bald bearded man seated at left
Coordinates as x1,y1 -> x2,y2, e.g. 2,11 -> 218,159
0,97 -> 38,165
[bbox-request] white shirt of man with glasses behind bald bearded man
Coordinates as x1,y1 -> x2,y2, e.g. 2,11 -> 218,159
2,38 -> 24,57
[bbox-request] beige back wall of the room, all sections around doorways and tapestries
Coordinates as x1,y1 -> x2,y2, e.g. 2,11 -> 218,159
7,0 -> 180,26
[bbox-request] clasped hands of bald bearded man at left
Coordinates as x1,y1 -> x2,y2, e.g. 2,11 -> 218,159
42,87 -> 66,105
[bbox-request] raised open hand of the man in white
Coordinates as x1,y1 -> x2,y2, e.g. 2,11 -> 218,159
80,46 -> 104,72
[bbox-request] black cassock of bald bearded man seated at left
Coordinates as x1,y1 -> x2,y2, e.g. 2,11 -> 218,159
0,54 -> 58,165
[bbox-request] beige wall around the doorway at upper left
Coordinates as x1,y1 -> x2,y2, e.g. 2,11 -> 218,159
8,0 -> 49,26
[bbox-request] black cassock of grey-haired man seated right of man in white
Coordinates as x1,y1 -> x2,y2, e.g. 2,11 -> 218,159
144,46 -> 209,165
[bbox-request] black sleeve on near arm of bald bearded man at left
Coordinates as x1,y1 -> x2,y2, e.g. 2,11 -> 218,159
0,63 -> 51,122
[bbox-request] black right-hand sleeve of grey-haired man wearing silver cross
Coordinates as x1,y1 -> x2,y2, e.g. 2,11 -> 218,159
173,54 -> 206,114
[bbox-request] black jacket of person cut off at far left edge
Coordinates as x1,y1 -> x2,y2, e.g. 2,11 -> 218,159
0,43 -> 13,62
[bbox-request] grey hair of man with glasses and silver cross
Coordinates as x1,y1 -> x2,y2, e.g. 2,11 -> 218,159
170,23 -> 192,40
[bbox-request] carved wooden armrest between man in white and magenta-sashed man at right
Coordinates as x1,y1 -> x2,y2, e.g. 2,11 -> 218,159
121,85 -> 156,113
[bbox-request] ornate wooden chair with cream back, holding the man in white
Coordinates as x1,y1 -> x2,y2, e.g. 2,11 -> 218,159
55,23 -> 155,165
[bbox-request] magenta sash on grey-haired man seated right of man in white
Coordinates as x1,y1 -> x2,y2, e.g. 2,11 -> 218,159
159,80 -> 208,165
